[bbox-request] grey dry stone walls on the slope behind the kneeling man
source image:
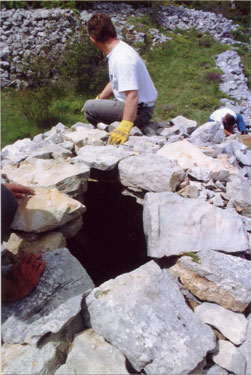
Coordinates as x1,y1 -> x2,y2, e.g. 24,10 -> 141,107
0,2 -> 251,126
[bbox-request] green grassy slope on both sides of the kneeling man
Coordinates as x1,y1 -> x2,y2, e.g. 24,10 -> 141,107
2,20 -> 248,147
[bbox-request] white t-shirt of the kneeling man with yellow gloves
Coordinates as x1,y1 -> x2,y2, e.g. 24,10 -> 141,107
107,40 -> 158,105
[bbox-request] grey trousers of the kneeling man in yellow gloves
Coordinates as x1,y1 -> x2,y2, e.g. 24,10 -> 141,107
84,99 -> 154,128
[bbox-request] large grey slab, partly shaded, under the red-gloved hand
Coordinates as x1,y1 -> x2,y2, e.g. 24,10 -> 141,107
2,248 -> 94,346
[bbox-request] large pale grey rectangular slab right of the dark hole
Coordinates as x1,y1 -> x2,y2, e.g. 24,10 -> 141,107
143,192 -> 249,258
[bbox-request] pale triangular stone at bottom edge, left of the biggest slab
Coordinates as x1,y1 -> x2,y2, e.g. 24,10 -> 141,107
55,329 -> 129,375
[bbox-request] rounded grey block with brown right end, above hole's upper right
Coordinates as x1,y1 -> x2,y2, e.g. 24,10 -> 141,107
119,154 -> 186,191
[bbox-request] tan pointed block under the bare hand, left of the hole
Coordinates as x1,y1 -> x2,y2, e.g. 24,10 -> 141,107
11,188 -> 86,233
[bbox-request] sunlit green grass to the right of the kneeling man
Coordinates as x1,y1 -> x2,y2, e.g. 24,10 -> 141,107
144,30 -> 228,124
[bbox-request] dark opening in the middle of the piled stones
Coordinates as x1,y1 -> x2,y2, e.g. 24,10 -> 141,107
68,178 -> 149,286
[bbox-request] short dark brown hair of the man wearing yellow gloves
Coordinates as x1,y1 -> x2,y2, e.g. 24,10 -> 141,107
87,13 -> 117,43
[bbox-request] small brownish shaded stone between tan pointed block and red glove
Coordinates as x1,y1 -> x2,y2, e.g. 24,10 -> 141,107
7,232 -> 66,260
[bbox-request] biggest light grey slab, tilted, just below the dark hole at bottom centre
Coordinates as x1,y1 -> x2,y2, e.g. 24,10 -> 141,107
84,261 -> 215,375
